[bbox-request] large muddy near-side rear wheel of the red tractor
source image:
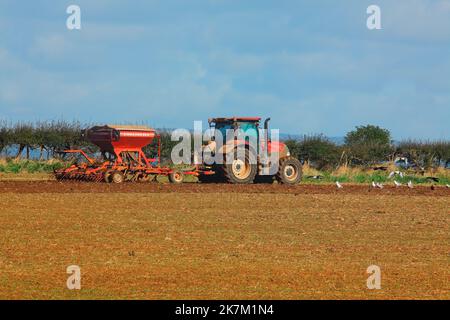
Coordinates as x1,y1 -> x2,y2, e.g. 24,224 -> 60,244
223,150 -> 258,184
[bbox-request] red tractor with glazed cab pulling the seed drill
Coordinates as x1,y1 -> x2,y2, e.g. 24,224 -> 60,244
198,117 -> 302,185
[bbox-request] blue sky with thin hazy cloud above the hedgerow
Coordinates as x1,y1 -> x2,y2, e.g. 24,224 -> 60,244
0,0 -> 450,139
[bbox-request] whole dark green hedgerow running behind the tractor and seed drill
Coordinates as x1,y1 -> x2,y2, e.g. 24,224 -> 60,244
0,120 -> 450,169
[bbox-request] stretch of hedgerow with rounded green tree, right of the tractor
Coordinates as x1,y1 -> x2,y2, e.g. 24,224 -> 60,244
286,125 -> 450,169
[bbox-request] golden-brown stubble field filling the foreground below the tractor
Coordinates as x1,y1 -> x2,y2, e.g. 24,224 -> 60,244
0,182 -> 450,299
